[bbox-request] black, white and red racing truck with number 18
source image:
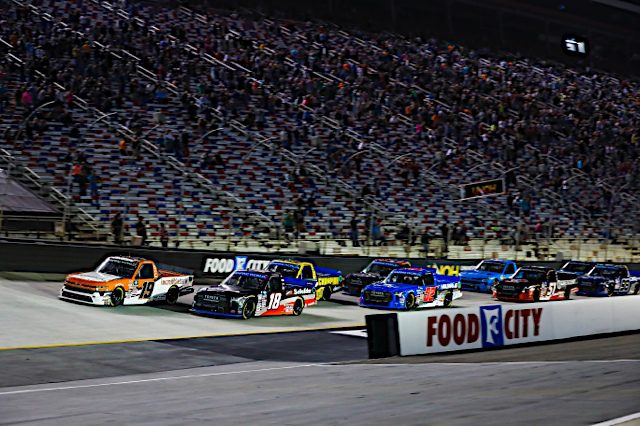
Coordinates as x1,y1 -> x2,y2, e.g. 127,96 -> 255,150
191,270 -> 316,319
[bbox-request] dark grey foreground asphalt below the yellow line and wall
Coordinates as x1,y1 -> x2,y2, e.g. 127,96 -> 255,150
0,332 -> 640,425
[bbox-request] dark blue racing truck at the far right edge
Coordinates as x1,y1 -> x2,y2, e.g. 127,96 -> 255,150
577,264 -> 640,296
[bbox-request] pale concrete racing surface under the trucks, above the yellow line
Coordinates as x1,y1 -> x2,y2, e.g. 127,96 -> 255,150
0,278 -> 516,349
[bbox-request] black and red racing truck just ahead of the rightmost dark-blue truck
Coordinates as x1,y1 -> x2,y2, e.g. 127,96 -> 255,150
493,266 -> 571,302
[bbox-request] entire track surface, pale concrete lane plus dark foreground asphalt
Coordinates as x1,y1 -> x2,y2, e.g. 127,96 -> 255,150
0,280 -> 640,426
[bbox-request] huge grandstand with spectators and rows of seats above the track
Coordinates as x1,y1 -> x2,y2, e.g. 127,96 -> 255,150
0,0 -> 640,259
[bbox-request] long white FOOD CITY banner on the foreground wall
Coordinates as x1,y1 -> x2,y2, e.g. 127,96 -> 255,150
388,296 -> 640,355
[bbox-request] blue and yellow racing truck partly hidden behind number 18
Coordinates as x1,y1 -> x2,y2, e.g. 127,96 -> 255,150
266,260 -> 342,300
